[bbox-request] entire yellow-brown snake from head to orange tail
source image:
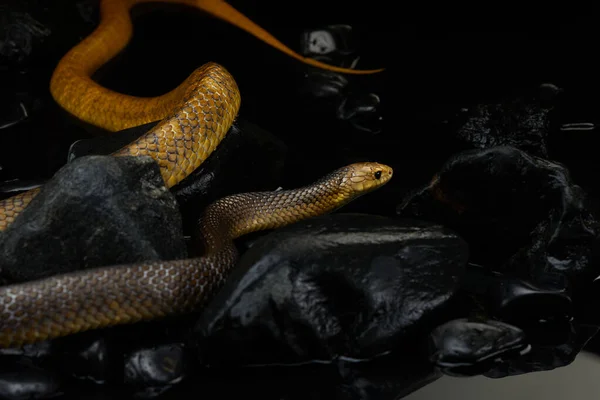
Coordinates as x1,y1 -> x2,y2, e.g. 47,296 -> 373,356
0,0 -> 392,347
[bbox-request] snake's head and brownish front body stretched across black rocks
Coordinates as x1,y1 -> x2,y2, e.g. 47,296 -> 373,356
0,163 -> 392,348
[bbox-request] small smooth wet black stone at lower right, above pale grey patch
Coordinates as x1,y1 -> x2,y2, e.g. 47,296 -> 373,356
431,319 -> 529,376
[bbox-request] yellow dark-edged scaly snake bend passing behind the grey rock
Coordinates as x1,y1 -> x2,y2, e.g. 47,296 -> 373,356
0,63 -> 241,231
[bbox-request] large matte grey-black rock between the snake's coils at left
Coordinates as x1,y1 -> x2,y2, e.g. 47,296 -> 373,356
0,156 -> 187,282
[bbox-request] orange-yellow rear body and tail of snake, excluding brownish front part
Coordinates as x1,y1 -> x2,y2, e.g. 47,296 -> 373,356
0,0 -> 383,231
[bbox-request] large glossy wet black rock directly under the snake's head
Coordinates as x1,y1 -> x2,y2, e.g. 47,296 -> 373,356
196,214 -> 468,365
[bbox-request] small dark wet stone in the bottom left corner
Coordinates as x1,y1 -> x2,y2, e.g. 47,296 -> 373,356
0,357 -> 60,400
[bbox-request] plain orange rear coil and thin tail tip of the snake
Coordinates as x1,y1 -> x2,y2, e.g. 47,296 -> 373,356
50,0 -> 381,131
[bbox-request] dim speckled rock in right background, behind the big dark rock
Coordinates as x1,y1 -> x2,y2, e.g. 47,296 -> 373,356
457,84 -> 560,157
